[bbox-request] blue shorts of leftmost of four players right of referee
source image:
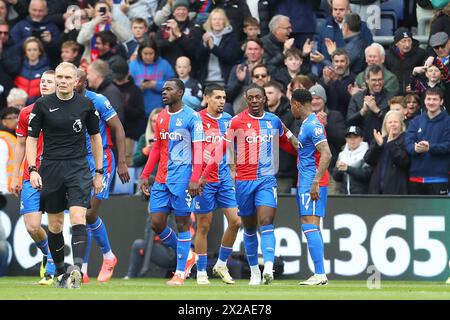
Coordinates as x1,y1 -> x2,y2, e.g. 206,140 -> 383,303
149,182 -> 194,216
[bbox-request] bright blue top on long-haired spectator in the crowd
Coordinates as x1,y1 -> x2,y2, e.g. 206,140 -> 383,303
130,57 -> 175,116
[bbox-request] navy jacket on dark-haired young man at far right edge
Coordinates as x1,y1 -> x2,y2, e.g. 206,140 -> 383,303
405,111 -> 450,183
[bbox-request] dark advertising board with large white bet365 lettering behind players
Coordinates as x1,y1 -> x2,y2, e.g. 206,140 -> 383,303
0,192 -> 450,281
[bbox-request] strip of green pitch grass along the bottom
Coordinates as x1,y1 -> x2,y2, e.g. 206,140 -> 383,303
0,277 -> 450,300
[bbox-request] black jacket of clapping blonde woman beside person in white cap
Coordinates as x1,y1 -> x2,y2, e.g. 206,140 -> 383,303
364,133 -> 409,194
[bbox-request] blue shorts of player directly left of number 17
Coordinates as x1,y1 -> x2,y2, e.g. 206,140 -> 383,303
236,176 -> 277,216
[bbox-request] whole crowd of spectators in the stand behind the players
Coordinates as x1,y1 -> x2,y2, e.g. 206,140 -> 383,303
0,0 -> 450,195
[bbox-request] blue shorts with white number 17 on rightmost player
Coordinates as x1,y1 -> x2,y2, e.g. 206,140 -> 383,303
297,187 -> 328,218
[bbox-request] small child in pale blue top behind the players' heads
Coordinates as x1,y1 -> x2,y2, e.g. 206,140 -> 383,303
175,56 -> 203,110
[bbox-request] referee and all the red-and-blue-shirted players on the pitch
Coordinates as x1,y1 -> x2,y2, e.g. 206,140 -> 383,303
12,63 -> 331,288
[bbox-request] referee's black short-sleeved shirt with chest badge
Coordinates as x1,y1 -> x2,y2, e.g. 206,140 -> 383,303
28,93 -> 99,160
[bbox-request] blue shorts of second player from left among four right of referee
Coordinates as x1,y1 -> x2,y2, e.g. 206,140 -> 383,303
194,179 -> 237,213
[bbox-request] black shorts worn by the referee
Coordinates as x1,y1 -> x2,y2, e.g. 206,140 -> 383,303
39,157 -> 92,213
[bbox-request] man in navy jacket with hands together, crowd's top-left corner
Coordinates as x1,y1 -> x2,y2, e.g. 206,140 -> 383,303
11,0 -> 61,65
